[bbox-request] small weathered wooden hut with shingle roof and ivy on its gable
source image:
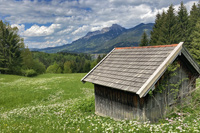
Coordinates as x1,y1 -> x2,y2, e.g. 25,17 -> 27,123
82,42 -> 200,121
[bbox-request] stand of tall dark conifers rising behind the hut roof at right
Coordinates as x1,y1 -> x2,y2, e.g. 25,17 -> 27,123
140,1 -> 200,64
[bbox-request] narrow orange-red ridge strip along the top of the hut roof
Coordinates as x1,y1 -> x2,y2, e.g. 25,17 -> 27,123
115,44 -> 178,49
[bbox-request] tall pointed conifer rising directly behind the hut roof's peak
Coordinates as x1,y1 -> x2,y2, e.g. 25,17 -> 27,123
177,2 -> 189,42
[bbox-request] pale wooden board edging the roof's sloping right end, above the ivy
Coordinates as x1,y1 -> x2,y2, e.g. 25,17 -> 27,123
136,42 -> 183,98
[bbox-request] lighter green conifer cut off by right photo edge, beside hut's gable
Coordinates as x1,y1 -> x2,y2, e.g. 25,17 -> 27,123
190,19 -> 200,64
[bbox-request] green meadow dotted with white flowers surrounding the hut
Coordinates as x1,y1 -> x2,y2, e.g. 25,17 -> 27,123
0,74 -> 200,133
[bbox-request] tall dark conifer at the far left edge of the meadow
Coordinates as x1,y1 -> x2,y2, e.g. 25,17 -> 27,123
0,21 -> 24,74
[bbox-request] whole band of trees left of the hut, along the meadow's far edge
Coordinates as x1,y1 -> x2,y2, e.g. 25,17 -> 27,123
0,20 -> 103,76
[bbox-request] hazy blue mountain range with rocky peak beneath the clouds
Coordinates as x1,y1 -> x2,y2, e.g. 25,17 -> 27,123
31,23 -> 154,54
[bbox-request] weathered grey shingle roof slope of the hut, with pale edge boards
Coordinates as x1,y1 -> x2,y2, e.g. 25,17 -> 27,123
82,43 -> 200,97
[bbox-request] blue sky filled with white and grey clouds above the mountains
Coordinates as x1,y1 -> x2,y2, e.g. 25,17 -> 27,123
0,0 -> 198,48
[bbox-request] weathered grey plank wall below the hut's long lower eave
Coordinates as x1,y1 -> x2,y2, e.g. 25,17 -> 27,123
95,85 -> 145,121
